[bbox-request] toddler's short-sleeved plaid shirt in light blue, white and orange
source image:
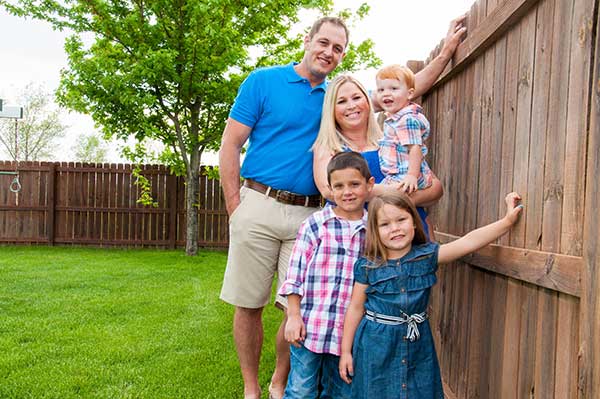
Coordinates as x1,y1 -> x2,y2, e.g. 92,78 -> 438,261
379,103 -> 433,190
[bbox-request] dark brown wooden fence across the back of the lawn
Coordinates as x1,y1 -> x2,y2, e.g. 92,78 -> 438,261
0,162 -> 229,248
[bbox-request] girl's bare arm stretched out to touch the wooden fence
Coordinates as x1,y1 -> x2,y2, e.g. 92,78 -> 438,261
438,193 -> 523,264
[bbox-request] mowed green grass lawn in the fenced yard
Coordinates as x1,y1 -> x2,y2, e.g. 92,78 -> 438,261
0,247 -> 281,399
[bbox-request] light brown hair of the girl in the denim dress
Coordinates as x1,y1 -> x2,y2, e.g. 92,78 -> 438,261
365,192 -> 427,265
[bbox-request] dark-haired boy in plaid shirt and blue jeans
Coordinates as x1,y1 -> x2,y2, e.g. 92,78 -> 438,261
279,152 -> 374,399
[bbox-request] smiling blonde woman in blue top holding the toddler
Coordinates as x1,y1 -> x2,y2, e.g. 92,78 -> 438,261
313,75 -> 443,238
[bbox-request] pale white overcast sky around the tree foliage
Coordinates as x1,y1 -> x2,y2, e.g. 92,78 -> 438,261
0,0 -> 474,164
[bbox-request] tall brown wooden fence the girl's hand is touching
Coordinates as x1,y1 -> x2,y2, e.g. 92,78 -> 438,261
423,0 -> 600,399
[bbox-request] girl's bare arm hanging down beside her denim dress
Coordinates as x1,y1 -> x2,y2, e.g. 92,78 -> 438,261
339,283 -> 368,384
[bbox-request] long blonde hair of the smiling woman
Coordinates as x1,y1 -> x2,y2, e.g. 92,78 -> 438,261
312,75 -> 381,153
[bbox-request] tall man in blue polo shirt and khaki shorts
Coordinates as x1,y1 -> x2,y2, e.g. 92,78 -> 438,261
219,17 -> 466,399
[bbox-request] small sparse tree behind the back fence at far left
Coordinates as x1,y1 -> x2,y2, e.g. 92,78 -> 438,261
0,84 -> 67,161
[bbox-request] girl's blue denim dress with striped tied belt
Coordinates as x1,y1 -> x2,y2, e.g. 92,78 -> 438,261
352,243 -> 444,399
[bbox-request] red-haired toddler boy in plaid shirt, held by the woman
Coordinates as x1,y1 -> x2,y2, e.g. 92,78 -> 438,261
376,65 -> 432,194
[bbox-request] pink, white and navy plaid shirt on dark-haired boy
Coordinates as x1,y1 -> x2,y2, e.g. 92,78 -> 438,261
279,206 -> 367,356
